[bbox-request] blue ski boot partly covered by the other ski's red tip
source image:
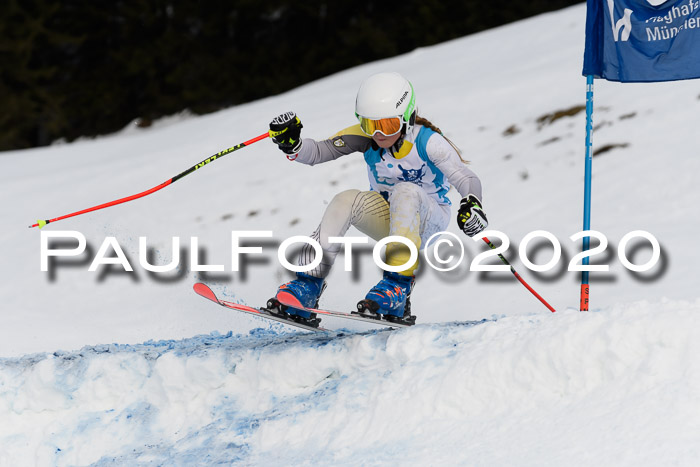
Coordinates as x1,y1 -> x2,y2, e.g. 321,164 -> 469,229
267,272 -> 326,327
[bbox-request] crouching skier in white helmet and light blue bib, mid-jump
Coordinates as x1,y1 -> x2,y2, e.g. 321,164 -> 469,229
267,73 -> 488,326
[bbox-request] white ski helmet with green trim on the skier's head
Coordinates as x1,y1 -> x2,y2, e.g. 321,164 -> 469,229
355,72 -> 416,136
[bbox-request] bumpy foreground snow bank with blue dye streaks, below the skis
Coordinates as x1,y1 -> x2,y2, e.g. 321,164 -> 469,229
0,301 -> 700,466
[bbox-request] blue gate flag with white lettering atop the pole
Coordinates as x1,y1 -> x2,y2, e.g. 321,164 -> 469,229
583,0 -> 700,82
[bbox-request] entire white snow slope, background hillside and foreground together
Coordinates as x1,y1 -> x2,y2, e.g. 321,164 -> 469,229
0,1 -> 700,465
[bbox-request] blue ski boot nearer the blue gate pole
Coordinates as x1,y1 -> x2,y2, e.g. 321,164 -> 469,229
353,271 -> 416,325
